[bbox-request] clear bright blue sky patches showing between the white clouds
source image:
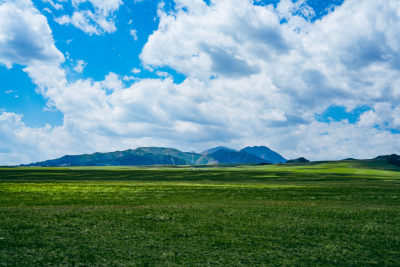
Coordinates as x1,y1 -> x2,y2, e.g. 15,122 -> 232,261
0,0 -> 346,127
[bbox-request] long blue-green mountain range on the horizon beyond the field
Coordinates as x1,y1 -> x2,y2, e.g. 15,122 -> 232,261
24,146 -> 286,167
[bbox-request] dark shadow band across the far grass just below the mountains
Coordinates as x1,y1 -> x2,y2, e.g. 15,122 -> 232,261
0,168 -> 400,183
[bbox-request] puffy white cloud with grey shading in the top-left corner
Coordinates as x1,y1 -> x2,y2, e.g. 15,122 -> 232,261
0,0 -> 66,102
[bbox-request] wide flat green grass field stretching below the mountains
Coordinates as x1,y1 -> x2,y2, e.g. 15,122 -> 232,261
0,161 -> 400,266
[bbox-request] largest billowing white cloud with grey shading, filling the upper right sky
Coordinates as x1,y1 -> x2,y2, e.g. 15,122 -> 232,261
141,0 -> 400,112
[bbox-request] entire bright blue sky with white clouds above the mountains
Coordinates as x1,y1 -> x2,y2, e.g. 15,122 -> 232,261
0,0 -> 400,165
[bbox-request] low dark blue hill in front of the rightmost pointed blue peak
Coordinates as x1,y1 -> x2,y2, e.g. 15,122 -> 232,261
208,149 -> 271,164
